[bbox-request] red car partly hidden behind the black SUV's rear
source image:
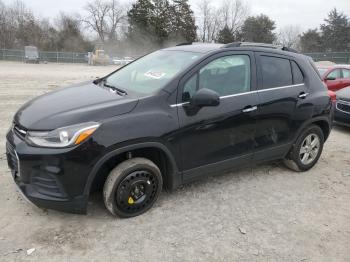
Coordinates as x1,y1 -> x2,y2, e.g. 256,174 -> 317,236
317,65 -> 350,91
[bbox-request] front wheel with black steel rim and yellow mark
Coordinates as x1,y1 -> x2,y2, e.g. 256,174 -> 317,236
103,158 -> 163,218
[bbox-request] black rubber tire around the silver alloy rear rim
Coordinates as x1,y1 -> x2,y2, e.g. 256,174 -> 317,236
284,125 -> 324,172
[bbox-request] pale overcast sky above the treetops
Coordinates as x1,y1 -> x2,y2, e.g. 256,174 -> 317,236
3,0 -> 350,30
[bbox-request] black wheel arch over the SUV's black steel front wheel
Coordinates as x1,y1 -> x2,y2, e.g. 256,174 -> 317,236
84,142 -> 182,197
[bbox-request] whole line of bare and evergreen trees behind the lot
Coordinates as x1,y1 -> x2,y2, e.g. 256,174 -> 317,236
0,0 -> 350,54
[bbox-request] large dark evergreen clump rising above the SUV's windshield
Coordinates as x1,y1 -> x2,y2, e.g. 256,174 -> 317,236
128,0 -> 197,48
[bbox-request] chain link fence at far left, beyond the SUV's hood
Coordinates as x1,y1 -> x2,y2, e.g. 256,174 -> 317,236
0,49 -> 88,63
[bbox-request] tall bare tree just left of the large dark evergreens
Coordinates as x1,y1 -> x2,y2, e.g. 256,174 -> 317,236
83,0 -> 126,43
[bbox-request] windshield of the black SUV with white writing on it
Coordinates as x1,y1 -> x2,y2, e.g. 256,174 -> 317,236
106,50 -> 202,94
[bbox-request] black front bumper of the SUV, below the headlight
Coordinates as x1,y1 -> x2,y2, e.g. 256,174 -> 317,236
6,129 -> 99,214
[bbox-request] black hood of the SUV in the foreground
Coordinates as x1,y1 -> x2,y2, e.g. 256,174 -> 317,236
14,82 -> 138,130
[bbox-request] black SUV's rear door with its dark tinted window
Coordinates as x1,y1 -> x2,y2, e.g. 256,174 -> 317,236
254,53 -> 312,162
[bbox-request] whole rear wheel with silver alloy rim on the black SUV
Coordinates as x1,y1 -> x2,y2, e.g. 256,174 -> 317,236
284,125 -> 324,171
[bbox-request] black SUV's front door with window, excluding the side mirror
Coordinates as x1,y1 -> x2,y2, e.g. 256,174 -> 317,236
178,52 -> 257,181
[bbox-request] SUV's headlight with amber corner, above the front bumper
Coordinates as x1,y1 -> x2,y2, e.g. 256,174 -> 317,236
26,122 -> 100,148
